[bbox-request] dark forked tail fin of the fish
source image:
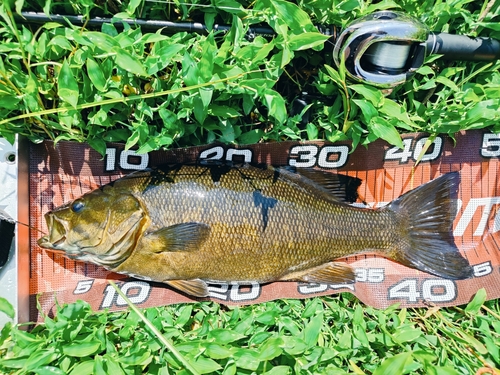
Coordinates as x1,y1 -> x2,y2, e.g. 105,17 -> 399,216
385,172 -> 473,280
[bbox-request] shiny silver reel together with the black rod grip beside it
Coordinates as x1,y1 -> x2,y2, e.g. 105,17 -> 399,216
333,11 -> 500,88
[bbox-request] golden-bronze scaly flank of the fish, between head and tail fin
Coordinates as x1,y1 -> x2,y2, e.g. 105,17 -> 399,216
126,167 -> 396,282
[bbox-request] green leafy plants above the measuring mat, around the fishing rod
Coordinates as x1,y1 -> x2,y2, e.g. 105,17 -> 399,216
0,0 -> 500,152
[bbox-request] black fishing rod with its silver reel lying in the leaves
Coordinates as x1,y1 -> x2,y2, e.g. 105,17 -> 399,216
17,11 -> 500,88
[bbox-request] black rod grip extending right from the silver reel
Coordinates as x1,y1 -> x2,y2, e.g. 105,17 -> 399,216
426,33 -> 500,61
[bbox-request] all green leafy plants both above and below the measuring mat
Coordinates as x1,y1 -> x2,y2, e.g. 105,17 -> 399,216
0,0 -> 500,375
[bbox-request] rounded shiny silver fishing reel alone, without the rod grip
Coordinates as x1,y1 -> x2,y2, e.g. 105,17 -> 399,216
333,11 -> 429,88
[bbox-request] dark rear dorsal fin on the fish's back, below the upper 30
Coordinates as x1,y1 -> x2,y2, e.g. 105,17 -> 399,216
276,167 -> 361,203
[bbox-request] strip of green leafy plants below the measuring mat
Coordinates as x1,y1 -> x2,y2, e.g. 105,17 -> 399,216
0,290 -> 500,375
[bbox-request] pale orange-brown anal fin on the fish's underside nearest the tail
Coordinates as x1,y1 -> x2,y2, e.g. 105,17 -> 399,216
282,262 -> 356,284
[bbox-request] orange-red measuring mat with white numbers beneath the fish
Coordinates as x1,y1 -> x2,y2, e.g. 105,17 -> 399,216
30,131 -> 500,320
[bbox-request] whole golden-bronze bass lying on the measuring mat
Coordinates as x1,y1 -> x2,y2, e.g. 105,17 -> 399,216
38,161 -> 473,297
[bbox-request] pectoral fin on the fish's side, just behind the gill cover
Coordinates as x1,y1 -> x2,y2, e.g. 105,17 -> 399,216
145,222 -> 210,253
